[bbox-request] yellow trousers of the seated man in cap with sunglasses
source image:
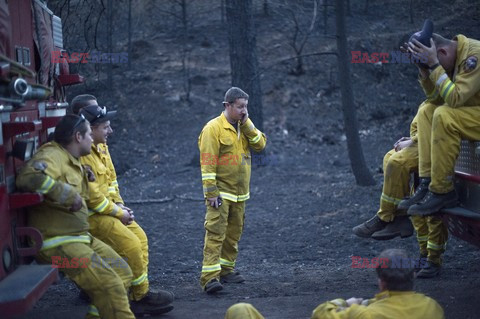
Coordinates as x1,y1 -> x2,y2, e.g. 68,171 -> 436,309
88,214 -> 149,301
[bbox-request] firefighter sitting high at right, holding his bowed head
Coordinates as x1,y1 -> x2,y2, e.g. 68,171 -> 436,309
401,30 -> 480,274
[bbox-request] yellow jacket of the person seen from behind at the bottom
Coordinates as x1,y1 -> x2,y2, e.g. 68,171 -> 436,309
312,290 -> 445,319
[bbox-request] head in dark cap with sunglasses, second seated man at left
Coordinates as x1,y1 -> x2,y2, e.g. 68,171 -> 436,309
80,105 -> 117,145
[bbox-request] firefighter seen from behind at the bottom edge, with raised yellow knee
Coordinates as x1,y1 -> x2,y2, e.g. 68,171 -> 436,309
225,249 -> 445,319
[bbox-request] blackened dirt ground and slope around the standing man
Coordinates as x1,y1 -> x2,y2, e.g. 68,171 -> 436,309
14,1 -> 480,319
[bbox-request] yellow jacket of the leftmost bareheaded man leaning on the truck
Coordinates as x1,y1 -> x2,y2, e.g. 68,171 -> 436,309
17,142 -> 90,249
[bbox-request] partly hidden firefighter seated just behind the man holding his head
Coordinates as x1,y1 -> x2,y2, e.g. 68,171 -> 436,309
353,47 -> 448,278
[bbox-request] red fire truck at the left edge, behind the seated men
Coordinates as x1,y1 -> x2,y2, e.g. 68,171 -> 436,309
0,0 -> 83,318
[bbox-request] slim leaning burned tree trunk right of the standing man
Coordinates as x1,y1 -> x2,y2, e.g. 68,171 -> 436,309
335,0 -> 375,186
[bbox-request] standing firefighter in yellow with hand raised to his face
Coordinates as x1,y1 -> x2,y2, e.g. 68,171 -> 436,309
198,87 -> 266,293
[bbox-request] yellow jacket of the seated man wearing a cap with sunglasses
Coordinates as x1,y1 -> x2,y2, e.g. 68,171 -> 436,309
80,144 -> 123,218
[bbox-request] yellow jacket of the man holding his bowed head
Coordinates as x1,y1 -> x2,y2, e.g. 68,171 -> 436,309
429,35 -> 480,107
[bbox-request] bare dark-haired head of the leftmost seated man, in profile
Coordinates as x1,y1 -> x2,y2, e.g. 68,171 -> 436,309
53,114 -> 93,158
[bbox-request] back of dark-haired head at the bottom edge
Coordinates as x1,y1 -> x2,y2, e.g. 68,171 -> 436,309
376,249 -> 415,291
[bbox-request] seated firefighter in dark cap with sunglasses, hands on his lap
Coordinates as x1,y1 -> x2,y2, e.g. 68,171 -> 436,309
72,99 -> 174,316
